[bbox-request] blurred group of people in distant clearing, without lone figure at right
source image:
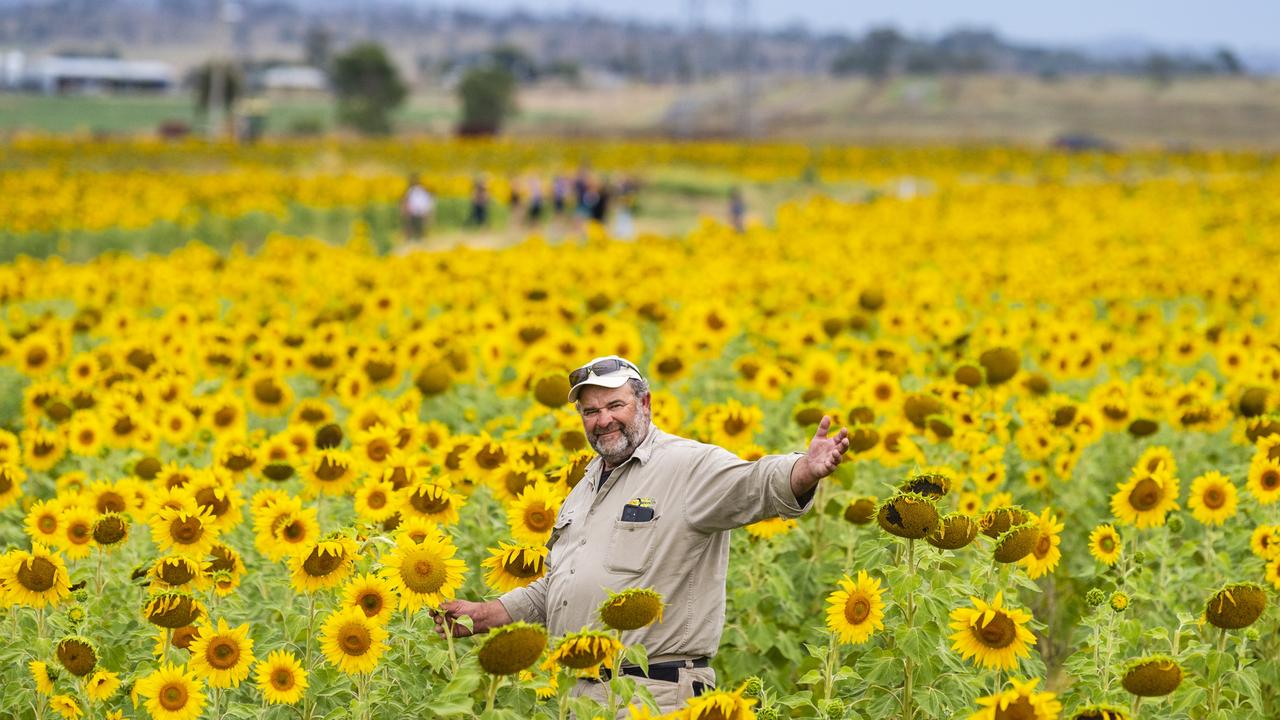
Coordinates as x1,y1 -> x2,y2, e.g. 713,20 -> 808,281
399,168 -> 640,242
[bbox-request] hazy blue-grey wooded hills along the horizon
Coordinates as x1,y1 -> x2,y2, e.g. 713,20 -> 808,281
0,0 -> 1259,83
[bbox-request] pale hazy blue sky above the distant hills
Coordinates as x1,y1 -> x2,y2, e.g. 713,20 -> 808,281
467,0 -> 1280,50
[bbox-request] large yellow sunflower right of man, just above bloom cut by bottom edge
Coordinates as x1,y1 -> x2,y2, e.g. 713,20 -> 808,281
950,592 -> 1036,670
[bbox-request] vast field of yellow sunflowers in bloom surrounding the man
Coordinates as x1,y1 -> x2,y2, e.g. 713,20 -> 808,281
0,138 -> 1280,720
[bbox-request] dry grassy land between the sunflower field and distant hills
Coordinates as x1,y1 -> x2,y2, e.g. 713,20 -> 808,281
0,76 -> 1280,149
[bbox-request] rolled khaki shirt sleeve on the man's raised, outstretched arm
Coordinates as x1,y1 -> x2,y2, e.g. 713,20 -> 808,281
685,445 -> 813,533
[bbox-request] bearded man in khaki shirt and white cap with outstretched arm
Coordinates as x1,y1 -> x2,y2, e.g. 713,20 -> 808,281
436,356 -> 849,712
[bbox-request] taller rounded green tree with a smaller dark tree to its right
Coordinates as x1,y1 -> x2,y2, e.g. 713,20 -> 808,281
333,42 -> 408,135
